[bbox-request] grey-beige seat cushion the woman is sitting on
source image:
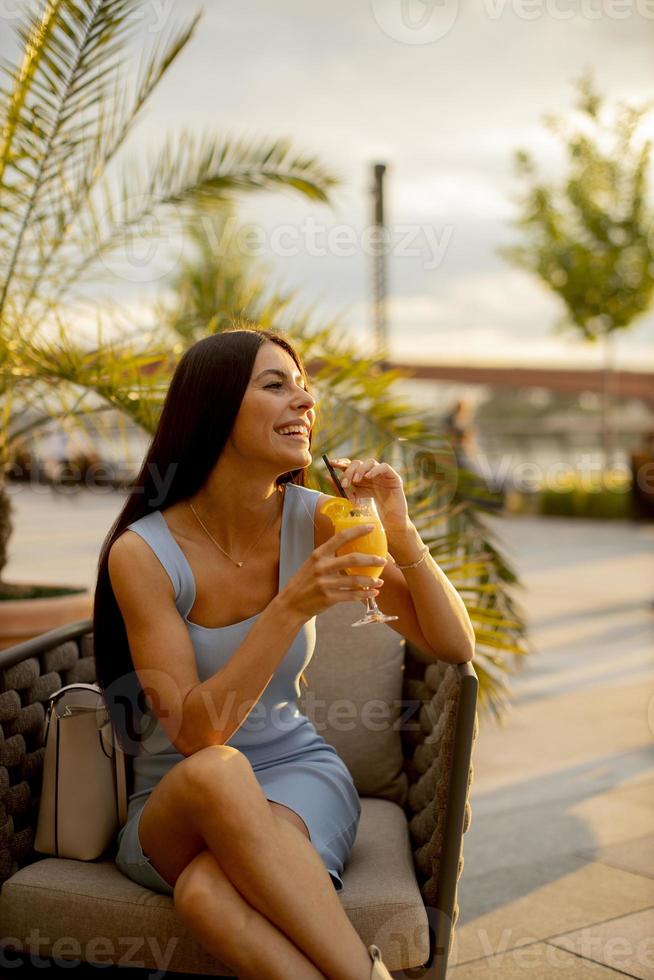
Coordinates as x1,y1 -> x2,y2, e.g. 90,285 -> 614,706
0,799 -> 428,976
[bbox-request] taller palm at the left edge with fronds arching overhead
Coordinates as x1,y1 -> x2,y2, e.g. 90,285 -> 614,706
0,0 -> 336,575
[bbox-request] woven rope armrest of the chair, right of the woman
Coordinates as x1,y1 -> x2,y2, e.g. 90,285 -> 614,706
402,642 -> 479,976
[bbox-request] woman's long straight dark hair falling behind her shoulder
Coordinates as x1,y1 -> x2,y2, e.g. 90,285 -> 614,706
93,327 -> 312,755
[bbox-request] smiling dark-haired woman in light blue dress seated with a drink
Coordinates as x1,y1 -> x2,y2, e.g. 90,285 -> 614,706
94,328 -> 472,980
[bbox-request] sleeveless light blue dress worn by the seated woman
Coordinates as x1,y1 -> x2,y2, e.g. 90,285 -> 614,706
115,483 -> 361,895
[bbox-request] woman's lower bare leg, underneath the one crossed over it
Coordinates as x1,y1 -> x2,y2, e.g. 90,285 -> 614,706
174,850 -> 324,980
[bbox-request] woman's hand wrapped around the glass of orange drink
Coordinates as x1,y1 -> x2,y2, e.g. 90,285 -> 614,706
277,524 -> 387,622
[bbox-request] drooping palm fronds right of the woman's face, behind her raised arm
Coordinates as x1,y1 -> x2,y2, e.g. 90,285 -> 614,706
262,323 -> 529,719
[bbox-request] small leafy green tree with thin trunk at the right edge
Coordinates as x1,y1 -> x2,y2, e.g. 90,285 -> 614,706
498,72 -> 654,467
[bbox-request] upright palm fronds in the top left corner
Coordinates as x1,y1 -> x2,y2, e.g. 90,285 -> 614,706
0,0 -> 198,324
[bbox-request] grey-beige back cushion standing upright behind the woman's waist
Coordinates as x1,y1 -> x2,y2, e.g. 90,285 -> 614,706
298,601 -> 408,806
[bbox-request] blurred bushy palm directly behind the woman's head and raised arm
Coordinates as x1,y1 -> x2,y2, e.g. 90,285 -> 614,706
26,193 -> 528,719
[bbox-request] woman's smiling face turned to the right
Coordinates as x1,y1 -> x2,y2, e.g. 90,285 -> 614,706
230,341 -> 316,475
